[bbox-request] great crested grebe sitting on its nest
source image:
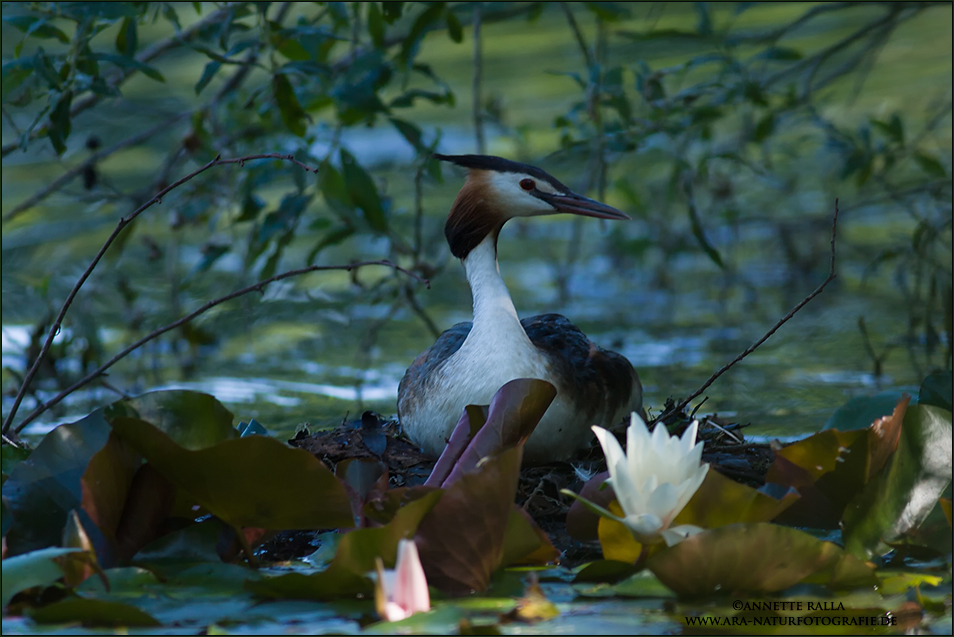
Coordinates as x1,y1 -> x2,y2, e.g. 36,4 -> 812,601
398,155 -> 643,464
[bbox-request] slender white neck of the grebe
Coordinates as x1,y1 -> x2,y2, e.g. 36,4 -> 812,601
462,234 -> 527,338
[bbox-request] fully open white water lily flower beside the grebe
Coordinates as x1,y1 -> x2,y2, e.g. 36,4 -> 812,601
593,412 -> 709,546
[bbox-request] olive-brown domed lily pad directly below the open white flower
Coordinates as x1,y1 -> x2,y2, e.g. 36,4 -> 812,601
647,523 -> 877,597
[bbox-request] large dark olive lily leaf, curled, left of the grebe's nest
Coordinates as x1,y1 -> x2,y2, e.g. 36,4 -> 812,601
110,417 -> 352,530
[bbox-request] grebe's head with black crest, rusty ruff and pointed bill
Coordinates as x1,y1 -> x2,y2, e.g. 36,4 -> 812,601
434,155 -> 629,259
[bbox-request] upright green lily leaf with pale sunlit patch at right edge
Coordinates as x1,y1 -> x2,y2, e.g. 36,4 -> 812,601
843,405 -> 952,559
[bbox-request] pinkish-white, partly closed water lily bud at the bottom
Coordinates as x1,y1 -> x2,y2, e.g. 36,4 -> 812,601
374,540 -> 431,622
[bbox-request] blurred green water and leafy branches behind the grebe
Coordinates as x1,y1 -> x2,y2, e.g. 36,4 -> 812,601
2,3 -> 952,435
